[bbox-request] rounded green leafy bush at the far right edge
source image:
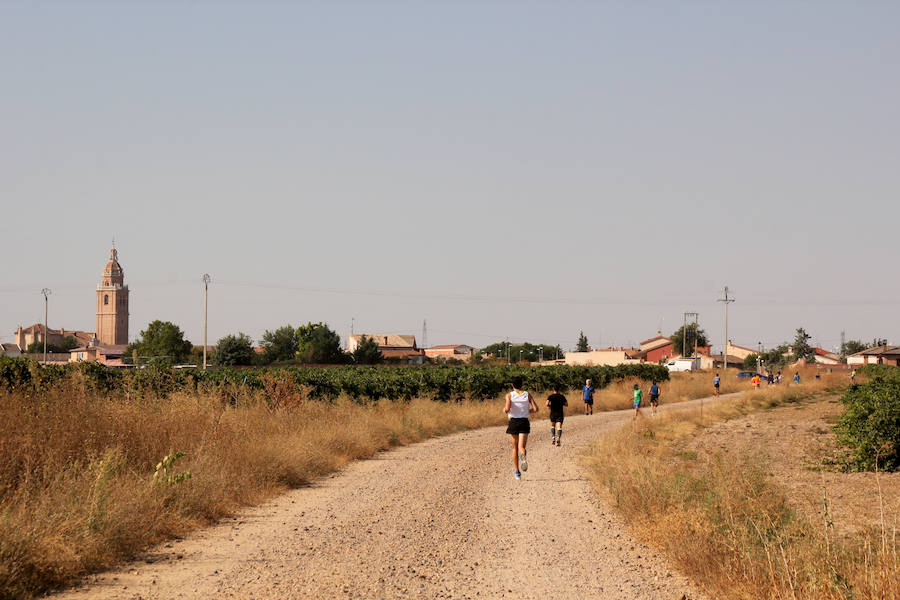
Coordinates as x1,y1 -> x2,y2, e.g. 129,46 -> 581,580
835,378 -> 900,471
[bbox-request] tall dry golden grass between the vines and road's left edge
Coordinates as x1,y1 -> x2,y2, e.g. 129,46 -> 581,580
0,386 -> 505,598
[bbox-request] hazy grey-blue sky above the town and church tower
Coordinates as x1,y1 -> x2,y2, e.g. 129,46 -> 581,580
0,0 -> 900,350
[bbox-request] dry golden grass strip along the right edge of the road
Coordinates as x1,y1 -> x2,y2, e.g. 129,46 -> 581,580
588,374 -> 900,599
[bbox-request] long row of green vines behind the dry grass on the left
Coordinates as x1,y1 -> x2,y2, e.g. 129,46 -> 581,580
0,356 -> 669,402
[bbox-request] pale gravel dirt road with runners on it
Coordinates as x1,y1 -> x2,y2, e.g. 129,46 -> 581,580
57,396 -> 724,600
